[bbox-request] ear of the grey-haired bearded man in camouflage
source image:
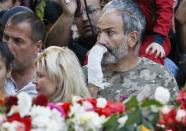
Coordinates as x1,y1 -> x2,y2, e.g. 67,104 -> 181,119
128,31 -> 138,48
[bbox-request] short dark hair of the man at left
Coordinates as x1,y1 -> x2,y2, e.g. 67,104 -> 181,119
9,12 -> 46,42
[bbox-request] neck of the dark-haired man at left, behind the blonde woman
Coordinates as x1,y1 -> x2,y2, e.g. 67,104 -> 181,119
12,65 -> 35,89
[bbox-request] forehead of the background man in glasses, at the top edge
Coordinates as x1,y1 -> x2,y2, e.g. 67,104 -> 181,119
80,0 -> 101,9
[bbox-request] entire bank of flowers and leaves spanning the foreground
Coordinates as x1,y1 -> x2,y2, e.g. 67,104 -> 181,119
0,87 -> 186,131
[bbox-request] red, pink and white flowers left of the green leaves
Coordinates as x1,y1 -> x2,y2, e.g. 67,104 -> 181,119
0,93 -> 125,131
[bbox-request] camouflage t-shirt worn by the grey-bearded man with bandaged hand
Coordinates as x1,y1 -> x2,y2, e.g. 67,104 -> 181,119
99,58 -> 178,101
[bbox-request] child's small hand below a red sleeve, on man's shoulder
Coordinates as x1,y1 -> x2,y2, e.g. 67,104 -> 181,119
145,42 -> 165,58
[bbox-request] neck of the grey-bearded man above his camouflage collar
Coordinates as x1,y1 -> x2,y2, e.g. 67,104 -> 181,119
106,54 -> 139,72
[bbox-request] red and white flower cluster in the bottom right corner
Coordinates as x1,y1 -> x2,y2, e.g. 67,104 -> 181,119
159,89 -> 186,131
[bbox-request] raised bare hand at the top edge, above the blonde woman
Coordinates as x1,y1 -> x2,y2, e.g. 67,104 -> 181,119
59,0 -> 77,16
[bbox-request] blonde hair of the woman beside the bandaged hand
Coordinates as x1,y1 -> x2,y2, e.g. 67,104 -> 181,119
35,46 -> 90,102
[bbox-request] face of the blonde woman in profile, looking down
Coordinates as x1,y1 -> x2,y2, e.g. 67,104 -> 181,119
36,66 -> 57,98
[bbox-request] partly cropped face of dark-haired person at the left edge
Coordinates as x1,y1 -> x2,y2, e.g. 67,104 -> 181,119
0,55 -> 8,89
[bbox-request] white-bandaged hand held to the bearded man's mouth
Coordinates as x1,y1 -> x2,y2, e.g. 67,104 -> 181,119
88,44 -> 107,88
